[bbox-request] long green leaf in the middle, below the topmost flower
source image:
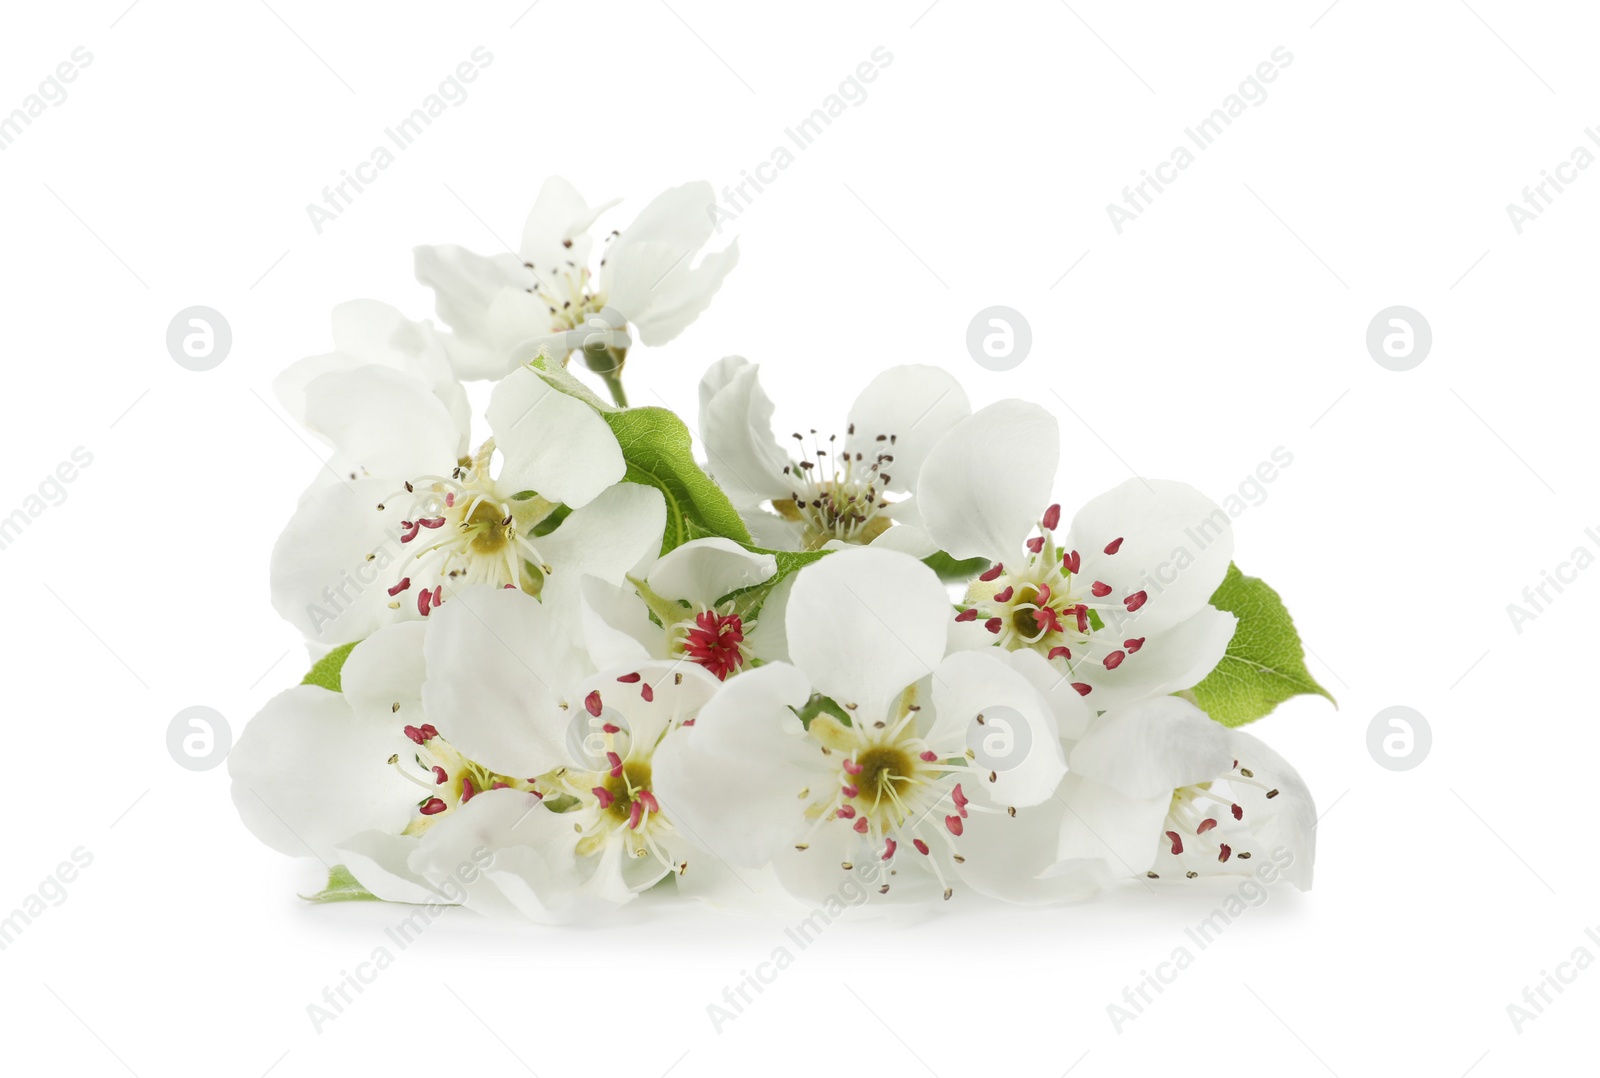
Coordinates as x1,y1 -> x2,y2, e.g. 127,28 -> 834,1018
533,360 -> 750,553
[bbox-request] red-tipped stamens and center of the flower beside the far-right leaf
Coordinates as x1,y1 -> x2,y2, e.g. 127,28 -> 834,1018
955,505 -> 1147,696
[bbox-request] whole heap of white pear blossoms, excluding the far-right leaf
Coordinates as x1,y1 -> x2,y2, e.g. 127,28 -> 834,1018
229,179 -> 1317,923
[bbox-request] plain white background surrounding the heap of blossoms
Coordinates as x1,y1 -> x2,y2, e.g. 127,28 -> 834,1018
0,0 -> 1600,1078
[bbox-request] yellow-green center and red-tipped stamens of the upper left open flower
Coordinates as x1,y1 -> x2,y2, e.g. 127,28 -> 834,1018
379,441 -> 555,616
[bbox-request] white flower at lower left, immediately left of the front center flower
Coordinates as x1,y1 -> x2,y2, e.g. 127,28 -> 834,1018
411,589 -> 720,921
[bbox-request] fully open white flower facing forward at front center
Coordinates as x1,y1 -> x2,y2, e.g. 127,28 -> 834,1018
654,549 -> 1066,897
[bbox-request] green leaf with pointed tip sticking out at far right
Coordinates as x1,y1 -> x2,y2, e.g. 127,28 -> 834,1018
1187,565 -> 1338,726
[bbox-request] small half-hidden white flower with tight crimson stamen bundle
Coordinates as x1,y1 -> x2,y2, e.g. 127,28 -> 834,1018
582,537 -> 778,680
